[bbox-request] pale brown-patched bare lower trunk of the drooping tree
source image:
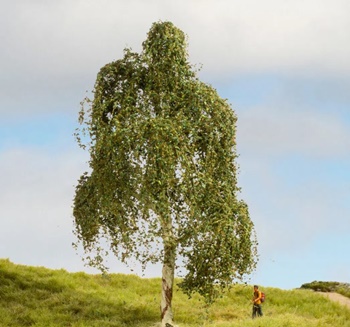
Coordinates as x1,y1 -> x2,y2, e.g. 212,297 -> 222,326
160,244 -> 176,327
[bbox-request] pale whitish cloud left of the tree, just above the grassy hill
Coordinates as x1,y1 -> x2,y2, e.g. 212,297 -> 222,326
0,148 -> 84,268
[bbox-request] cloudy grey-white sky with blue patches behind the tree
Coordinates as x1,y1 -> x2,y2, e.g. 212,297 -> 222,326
0,0 -> 350,289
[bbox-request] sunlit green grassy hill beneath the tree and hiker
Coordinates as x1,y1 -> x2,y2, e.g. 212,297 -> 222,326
0,260 -> 350,327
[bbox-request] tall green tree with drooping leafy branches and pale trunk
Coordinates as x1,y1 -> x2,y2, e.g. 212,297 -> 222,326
73,22 -> 257,326
